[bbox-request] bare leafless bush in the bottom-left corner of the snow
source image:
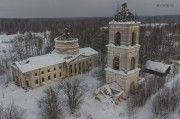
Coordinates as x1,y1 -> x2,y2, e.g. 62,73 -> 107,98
2,103 -> 25,119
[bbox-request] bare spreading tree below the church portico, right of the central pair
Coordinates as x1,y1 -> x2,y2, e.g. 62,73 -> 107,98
59,79 -> 84,114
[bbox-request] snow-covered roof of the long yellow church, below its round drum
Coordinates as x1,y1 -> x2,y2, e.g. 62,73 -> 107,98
15,47 -> 98,73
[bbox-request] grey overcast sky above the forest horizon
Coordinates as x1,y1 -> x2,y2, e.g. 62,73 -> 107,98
0,0 -> 180,18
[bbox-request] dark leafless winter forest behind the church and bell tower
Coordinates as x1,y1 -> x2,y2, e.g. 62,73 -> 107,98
0,16 -> 180,79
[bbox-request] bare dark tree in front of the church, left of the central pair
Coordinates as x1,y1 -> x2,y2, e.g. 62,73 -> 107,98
38,86 -> 61,119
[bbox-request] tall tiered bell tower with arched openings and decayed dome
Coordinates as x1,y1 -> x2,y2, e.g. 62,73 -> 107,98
105,3 -> 140,98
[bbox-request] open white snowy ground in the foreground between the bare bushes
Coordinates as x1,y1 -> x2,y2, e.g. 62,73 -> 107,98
0,68 -> 180,119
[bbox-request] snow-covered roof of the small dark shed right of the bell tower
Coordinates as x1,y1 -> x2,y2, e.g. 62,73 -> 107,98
145,60 -> 170,73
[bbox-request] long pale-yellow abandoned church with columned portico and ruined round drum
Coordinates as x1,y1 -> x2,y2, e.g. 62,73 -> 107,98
11,29 -> 98,89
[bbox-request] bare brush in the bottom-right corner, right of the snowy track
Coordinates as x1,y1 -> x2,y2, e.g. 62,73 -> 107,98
152,81 -> 180,119
